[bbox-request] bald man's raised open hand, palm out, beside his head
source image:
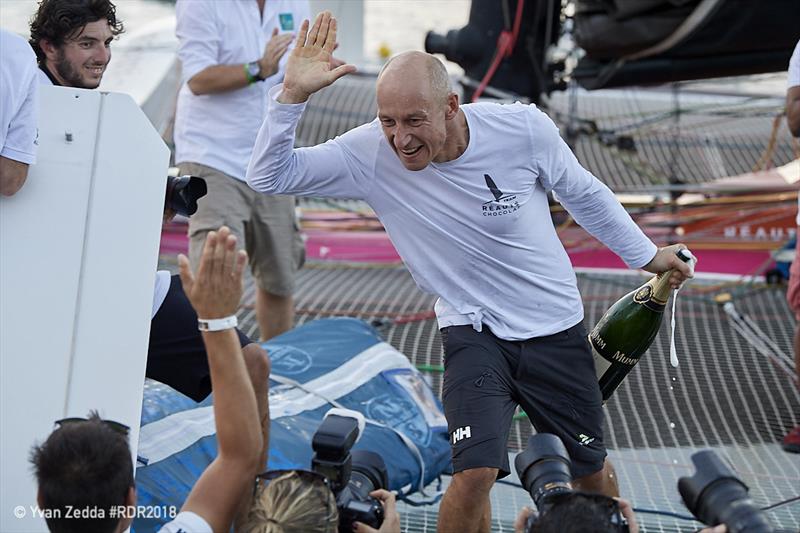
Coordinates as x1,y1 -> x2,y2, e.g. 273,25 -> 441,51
278,11 -> 356,104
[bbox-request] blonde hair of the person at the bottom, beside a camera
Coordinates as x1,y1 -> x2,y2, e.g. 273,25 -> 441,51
241,472 -> 339,533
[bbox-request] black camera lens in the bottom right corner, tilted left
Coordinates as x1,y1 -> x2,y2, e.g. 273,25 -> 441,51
678,450 -> 773,533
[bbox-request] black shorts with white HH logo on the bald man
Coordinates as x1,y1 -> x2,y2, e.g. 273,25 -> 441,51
442,323 -> 606,479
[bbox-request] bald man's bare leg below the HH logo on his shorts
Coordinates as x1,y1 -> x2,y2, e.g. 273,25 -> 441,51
436,468 -> 497,533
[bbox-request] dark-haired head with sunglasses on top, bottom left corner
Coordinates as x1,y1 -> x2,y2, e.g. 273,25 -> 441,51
31,412 -> 136,533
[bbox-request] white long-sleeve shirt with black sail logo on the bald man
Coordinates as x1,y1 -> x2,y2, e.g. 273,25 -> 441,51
247,86 -> 656,340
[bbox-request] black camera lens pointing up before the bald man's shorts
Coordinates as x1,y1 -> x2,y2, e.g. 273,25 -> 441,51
514,433 -> 572,513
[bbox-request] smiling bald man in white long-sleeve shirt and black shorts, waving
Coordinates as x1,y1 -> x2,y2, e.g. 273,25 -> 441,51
247,12 -> 691,533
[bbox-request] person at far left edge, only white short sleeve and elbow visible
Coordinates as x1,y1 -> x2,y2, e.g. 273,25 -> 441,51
0,30 -> 39,196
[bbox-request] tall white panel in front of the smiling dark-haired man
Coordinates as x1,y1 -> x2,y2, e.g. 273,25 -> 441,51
0,87 -> 169,533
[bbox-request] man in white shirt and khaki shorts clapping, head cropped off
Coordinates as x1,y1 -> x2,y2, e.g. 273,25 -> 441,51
175,0 -> 309,340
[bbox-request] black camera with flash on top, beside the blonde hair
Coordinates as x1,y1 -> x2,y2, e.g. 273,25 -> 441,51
311,411 -> 389,533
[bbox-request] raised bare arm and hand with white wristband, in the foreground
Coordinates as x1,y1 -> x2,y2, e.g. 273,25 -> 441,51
178,226 -> 261,531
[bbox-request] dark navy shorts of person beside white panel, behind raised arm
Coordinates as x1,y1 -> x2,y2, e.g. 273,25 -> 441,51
145,276 -> 253,402
